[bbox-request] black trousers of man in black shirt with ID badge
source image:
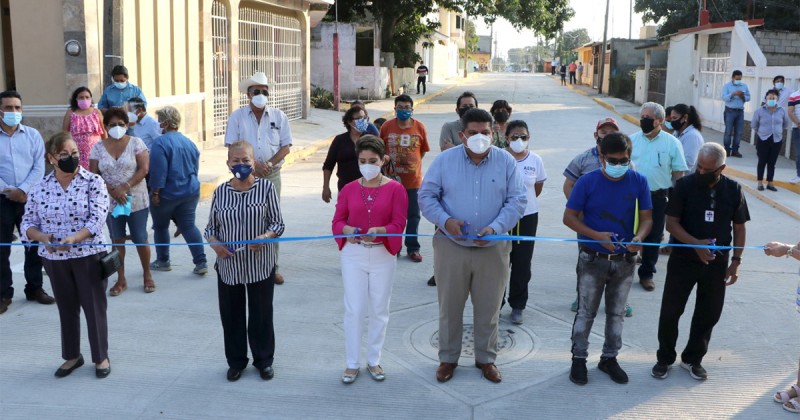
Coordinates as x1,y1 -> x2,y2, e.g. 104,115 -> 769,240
656,254 -> 728,365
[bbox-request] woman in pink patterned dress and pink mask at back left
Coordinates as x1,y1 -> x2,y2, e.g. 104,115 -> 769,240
61,86 -> 106,169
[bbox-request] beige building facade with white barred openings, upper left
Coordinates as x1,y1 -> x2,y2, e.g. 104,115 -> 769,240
0,0 -> 333,147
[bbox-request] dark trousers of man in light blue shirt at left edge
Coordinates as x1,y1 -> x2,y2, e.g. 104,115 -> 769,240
0,196 -> 43,299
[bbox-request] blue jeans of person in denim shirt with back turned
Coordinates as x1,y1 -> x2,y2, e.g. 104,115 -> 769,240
150,195 -> 206,265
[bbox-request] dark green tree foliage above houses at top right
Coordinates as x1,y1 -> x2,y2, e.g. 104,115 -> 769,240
633,0 -> 800,36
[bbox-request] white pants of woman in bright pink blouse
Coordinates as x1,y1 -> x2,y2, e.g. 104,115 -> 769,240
342,243 -> 397,369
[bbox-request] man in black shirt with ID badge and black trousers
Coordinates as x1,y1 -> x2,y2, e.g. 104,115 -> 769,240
652,143 -> 750,380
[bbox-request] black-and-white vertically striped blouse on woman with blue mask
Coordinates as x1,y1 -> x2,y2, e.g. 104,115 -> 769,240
205,178 -> 284,286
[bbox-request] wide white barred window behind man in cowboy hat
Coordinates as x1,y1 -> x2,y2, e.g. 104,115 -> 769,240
239,6 -> 303,119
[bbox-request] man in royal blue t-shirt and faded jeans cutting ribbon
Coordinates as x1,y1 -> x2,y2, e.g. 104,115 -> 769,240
564,133 -> 653,385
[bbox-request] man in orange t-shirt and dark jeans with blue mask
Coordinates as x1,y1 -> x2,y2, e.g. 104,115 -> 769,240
381,95 -> 431,262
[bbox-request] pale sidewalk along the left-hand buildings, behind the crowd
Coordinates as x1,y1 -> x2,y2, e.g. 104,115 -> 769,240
198,73 -> 477,200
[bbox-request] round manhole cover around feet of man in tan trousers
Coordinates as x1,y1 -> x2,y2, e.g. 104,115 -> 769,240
410,320 -> 535,366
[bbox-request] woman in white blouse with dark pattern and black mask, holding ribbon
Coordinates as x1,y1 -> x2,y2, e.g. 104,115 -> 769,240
20,133 -> 111,378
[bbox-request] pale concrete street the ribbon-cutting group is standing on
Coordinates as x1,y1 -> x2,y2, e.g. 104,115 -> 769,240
0,74 -> 800,419
